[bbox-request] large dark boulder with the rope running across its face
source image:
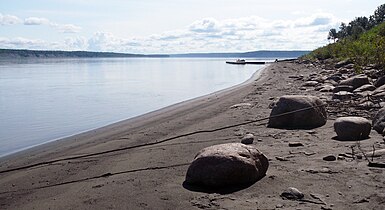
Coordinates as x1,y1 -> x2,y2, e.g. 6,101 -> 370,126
268,95 -> 327,129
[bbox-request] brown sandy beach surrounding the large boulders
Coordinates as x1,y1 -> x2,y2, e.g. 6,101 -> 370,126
0,63 -> 385,209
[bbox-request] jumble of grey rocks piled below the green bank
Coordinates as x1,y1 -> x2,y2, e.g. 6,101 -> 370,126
296,60 -> 385,111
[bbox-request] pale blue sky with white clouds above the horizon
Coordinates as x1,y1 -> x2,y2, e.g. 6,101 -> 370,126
0,0 -> 384,54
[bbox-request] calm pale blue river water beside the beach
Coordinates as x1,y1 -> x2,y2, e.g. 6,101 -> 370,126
0,58 -> 263,156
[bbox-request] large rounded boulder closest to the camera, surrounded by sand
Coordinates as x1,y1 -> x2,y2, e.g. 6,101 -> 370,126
186,143 -> 269,187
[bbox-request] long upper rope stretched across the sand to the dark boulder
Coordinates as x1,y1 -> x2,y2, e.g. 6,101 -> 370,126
0,104 -> 327,174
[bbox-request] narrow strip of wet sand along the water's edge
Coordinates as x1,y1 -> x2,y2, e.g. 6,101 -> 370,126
0,64 -> 269,162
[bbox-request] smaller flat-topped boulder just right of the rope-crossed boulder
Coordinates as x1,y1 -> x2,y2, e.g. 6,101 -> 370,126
334,117 -> 372,141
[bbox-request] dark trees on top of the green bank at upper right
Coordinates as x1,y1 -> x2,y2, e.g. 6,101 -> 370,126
328,4 -> 385,42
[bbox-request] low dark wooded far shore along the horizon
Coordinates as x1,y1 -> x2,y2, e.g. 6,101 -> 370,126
0,49 -> 310,59
